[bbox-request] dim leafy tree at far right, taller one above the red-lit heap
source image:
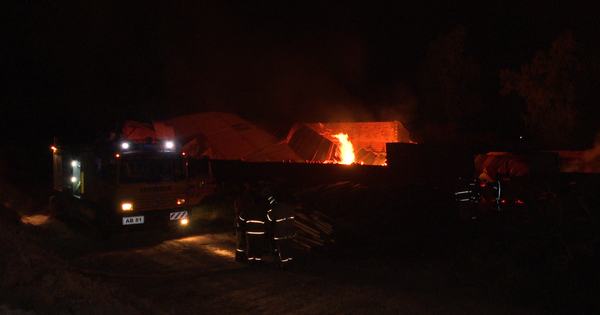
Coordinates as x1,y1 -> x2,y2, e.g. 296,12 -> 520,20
500,31 -> 582,148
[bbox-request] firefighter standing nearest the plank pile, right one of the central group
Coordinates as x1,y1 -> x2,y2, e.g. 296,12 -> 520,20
267,192 -> 296,269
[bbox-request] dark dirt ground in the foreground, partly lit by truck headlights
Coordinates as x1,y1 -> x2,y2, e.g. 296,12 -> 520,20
0,175 -> 597,314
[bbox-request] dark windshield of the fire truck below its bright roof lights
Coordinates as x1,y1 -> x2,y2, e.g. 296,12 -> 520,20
120,155 -> 185,183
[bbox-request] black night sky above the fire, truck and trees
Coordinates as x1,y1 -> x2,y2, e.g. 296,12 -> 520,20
0,0 -> 600,170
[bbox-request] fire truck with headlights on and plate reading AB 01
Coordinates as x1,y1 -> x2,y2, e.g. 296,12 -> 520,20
50,121 -> 212,238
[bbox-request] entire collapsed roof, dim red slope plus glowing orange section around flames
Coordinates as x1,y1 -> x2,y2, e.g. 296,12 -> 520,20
165,112 -> 412,165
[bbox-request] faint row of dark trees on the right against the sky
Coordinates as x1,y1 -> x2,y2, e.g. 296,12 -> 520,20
417,26 -> 600,149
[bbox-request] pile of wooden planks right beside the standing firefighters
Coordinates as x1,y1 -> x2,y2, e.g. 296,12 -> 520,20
294,208 -> 335,251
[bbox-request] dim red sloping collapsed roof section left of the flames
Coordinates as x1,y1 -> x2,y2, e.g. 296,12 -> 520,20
166,112 -> 304,162
